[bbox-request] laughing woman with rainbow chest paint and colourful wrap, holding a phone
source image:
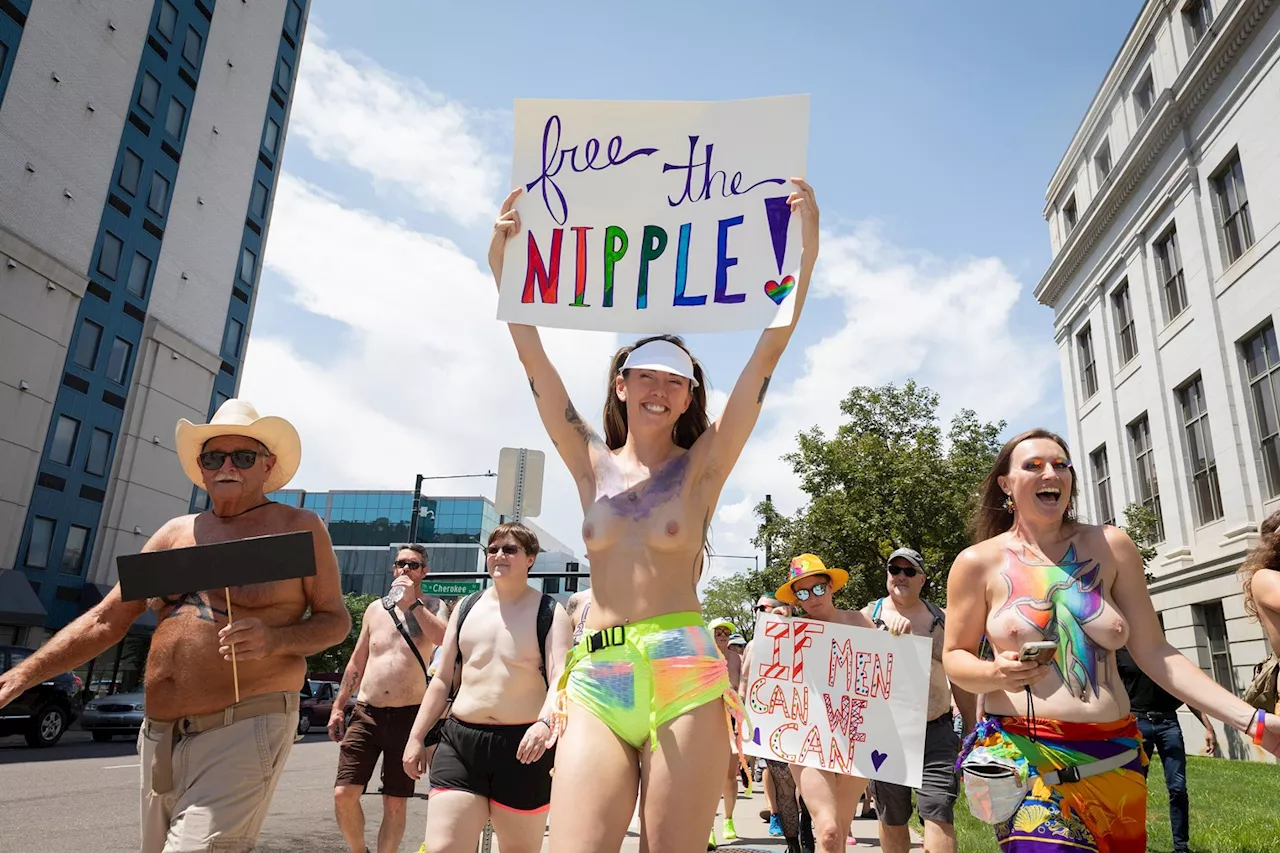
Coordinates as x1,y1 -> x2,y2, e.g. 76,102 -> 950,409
943,429 -> 1280,853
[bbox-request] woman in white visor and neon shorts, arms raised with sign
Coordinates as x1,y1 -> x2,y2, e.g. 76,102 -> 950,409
489,178 -> 818,853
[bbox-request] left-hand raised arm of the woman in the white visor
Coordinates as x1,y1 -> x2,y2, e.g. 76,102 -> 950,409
489,188 -> 608,506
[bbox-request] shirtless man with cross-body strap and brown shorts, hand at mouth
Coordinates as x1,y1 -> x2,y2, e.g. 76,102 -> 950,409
329,543 -> 449,853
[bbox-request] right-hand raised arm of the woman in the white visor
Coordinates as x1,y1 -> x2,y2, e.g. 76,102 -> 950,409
694,178 -> 818,485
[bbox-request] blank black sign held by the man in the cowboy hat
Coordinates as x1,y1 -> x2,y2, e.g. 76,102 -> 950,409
115,530 -> 316,601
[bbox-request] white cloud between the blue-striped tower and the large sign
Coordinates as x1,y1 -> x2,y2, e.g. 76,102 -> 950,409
289,33 -> 500,224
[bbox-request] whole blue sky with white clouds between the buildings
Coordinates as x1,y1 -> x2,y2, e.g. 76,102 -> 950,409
242,0 -> 1140,570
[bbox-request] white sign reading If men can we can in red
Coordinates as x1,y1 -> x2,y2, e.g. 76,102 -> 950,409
742,613 -> 933,788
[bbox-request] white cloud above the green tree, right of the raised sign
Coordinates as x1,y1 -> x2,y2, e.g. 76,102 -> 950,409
713,224 -> 1057,574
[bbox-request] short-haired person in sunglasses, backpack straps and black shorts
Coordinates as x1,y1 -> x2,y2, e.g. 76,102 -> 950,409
403,521 -> 573,853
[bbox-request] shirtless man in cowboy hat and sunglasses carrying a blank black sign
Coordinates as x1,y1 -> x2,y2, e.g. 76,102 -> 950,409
0,400 -> 351,853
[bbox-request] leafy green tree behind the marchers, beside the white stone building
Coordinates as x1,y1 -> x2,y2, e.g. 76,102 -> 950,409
749,382 -> 1005,607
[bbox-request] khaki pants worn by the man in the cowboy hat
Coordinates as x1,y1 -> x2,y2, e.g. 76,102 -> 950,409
138,693 -> 298,853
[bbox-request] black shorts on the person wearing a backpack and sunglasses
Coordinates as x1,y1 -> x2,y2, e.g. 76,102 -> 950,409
431,717 -> 556,812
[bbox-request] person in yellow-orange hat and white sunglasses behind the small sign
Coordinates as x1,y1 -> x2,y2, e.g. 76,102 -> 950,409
774,553 -> 873,853
